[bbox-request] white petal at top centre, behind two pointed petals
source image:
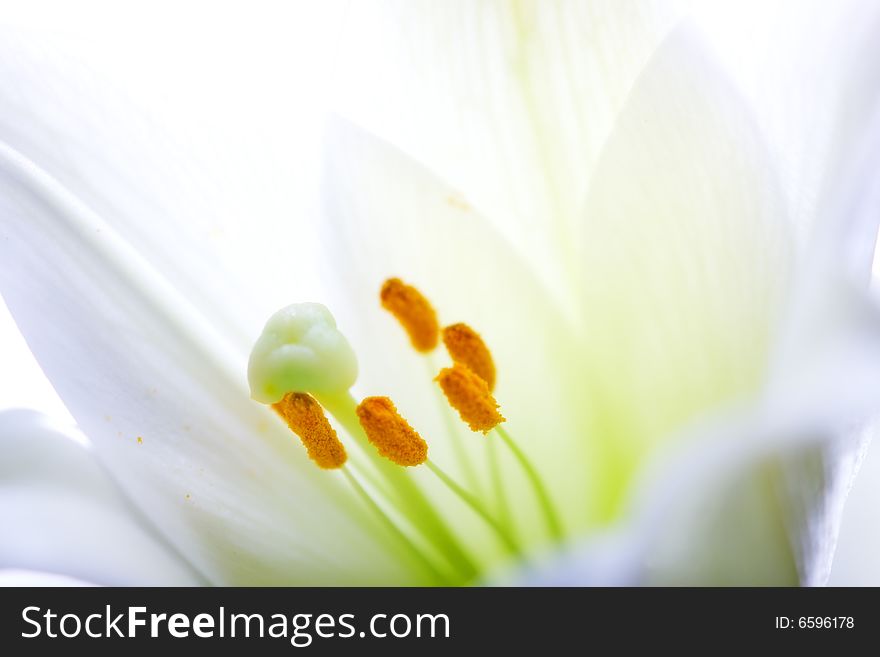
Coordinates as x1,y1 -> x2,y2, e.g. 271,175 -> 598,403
334,0 -> 686,296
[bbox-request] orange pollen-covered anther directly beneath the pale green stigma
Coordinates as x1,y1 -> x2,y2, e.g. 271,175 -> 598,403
272,392 -> 348,470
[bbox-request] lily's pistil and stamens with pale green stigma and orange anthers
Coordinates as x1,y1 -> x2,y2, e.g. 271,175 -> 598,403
248,278 -> 563,583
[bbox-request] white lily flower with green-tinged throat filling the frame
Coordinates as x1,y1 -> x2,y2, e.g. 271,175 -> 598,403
0,2 -> 880,584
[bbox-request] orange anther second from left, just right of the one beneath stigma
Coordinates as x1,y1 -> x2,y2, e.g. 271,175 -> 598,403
357,397 -> 428,466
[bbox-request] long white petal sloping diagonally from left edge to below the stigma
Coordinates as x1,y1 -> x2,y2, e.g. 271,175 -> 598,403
0,141 -> 418,584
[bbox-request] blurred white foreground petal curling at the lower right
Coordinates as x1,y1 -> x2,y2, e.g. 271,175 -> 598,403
512,288 -> 880,585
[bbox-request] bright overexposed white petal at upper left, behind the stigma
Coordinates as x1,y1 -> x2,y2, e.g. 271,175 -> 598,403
0,7 -> 341,349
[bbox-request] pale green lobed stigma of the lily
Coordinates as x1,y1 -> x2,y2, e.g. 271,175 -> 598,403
248,303 -> 358,404
